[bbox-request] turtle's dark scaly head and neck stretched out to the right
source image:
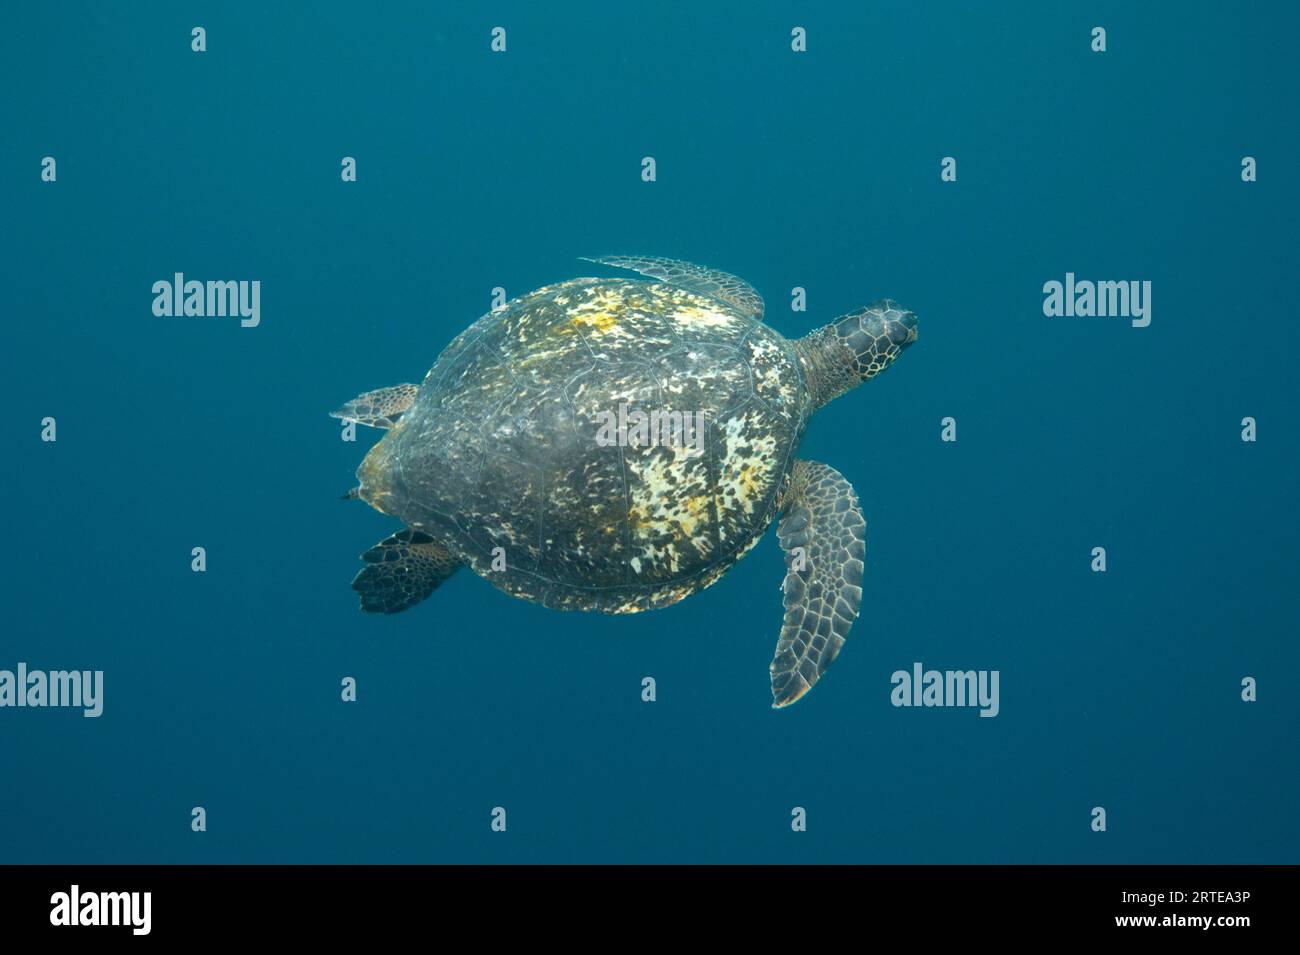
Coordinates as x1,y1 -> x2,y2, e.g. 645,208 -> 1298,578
794,299 -> 917,408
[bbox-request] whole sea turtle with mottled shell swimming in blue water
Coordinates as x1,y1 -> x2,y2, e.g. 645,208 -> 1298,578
333,256 -> 917,707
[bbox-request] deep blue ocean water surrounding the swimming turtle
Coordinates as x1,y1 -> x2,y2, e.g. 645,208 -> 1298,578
0,3 -> 1300,863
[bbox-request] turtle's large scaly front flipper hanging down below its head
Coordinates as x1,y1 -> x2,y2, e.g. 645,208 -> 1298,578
770,461 -> 867,707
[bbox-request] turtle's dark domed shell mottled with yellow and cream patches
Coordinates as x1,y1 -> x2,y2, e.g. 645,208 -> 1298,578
359,278 -> 809,613
